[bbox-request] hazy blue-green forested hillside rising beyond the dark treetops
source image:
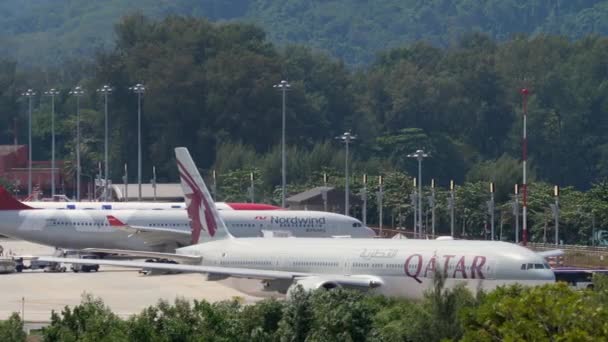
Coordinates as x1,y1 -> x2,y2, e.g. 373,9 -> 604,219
0,0 -> 608,67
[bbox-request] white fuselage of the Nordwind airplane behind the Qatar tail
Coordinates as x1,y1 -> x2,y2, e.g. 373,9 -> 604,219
0,209 -> 374,252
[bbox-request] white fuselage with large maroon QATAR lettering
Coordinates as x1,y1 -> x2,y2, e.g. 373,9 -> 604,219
177,238 -> 555,298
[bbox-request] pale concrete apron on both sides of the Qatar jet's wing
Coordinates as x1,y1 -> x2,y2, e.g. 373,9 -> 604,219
0,239 -> 260,321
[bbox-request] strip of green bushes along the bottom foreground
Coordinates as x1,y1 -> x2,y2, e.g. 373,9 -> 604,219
19,276 -> 608,342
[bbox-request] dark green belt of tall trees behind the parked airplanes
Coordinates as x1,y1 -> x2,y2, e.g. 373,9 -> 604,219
0,15 -> 608,239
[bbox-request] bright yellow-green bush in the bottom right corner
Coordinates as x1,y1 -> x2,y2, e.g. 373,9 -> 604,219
463,283 -> 608,341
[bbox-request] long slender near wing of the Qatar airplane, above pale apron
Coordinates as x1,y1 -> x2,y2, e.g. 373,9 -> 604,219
38,253 -> 383,289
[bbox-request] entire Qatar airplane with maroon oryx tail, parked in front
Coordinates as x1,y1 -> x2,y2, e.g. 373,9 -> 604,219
40,148 -> 555,298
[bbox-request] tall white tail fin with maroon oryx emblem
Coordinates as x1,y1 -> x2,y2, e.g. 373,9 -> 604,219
175,147 -> 232,244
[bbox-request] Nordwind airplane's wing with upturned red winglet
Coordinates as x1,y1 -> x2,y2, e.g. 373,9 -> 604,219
107,215 -> 191,246
